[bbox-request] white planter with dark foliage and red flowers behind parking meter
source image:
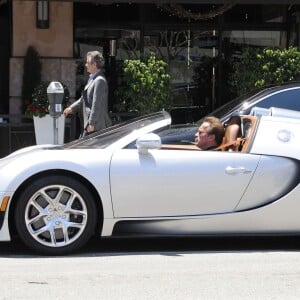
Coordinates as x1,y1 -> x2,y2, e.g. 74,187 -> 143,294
25,81 -> 70,144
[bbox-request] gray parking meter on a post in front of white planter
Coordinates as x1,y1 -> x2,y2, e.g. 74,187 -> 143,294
47,81 -> 64,145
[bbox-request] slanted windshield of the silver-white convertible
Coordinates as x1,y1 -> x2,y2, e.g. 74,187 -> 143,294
63,111 -> 170,149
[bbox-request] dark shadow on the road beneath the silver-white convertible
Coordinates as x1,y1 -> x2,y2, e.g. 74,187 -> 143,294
0,236 -> 300,257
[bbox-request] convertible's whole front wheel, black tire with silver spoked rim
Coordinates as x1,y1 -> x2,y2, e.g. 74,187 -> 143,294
15,175 -> 97,255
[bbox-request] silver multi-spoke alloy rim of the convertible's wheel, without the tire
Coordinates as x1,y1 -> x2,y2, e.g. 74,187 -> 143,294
24,185 -> 88,248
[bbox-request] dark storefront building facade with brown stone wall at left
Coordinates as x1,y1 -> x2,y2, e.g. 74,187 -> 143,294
0,0 -> 300,149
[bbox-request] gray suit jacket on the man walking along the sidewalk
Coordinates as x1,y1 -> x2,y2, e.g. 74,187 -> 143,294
71,72 -> 111,131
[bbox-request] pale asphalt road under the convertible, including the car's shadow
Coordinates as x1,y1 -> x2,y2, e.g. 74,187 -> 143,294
0,237 -> 300,300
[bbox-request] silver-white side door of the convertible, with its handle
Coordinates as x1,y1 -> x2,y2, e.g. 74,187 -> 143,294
110,149 -> 260,218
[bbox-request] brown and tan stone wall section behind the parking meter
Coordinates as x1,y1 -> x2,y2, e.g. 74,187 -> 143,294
9,0 -> 76,114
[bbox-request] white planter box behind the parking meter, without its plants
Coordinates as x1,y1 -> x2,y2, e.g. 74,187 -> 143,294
33,115 -> 65,145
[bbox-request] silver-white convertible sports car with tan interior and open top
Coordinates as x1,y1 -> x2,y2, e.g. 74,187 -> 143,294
0,107 -> 300,255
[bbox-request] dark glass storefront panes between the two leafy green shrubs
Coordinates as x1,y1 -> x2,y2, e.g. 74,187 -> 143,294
144,29 -> 218,122
